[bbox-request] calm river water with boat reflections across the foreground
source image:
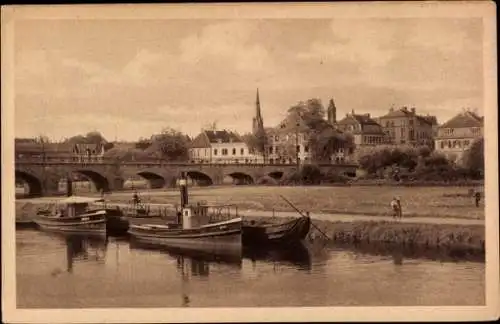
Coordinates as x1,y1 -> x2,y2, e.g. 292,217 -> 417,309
16,229 -> 485,308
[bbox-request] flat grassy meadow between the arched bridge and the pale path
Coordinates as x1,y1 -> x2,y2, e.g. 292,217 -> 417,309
98,186 -> 484,219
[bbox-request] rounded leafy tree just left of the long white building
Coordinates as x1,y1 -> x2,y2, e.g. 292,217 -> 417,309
145,128 -> 189,161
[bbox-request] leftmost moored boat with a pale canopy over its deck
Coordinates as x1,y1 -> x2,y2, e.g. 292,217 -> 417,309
34,196 -> 106,235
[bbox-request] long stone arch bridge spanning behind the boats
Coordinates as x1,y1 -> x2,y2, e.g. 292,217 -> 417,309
15,161 -> 357,196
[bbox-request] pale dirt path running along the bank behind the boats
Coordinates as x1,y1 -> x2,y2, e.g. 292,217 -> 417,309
17,198 -> 484,226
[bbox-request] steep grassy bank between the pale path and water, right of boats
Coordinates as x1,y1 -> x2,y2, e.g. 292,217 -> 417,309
247,217 -> 485,261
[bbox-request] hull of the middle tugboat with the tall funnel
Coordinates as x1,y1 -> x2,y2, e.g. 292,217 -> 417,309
128,219 -> 241,253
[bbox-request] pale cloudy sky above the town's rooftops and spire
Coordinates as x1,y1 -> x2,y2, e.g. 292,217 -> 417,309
14,18 -> 484,141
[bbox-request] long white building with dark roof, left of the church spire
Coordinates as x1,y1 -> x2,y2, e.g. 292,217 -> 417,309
189,130 -> 262,163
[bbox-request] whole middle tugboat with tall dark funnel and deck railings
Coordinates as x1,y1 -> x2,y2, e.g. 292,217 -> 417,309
128,172 -> 242,253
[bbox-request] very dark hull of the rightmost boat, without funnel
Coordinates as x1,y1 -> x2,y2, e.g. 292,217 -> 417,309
242,217 -> 311,246
